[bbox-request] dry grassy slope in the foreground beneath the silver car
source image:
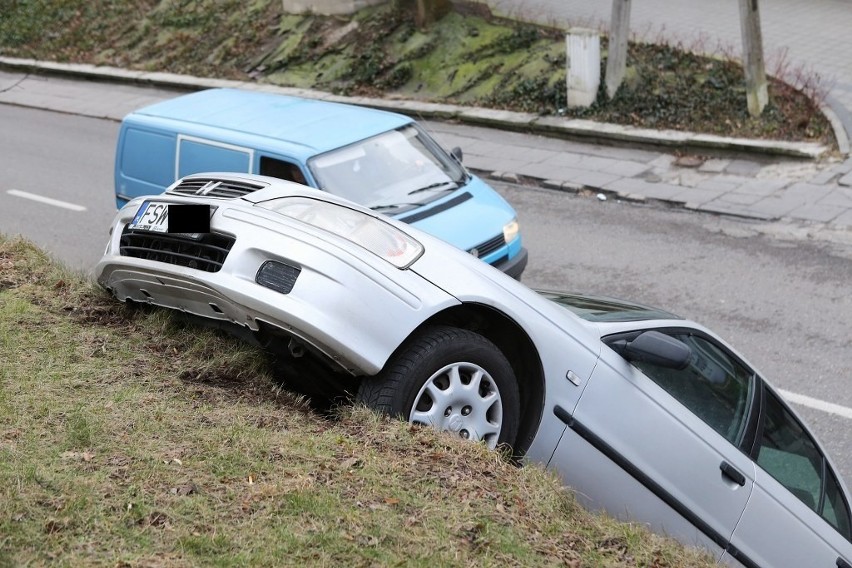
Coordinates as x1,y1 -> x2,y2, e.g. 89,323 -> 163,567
0,236 -> 712,567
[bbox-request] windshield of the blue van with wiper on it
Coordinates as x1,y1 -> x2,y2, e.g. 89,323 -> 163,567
308,124 -> 468,213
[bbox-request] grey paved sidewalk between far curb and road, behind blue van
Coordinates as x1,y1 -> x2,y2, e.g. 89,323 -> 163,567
5,61 -> 852,237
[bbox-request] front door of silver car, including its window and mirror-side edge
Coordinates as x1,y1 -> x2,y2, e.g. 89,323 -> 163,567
550,329 -> 756,557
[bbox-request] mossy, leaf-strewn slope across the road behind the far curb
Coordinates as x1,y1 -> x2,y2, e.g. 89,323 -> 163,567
0,0 -> 833,144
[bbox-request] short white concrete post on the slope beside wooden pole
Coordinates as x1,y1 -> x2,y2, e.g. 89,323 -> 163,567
565,28 -> 601,107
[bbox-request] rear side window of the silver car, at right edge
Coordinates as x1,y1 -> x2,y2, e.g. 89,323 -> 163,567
755,391 -> 850,538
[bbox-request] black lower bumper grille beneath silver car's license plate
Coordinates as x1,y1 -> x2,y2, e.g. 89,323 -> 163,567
119,227 -> 236,272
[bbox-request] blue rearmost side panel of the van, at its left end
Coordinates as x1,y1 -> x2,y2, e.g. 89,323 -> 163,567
115,125 -> 175,204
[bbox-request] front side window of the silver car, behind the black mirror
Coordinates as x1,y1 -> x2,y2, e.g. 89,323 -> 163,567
634,333 -> 754,446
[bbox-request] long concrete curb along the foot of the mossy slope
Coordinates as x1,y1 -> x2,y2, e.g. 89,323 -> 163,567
0,57 -> 849,160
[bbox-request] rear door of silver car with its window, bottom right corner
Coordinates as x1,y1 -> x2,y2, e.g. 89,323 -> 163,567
732,387 -> 852,568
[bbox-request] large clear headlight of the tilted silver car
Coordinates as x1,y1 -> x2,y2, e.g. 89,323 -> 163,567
257,197 -> 423,268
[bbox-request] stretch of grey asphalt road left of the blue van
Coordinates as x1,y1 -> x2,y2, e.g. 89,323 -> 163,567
0,105 -> 118,271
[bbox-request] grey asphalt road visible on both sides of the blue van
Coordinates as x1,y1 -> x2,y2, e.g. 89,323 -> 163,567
0,96 -> 852,484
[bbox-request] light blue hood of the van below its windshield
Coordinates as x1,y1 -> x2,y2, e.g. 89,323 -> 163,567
396,176 -> 515,250
